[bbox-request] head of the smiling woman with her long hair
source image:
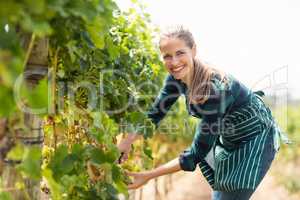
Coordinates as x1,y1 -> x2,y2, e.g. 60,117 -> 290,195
159,26 -> 225,103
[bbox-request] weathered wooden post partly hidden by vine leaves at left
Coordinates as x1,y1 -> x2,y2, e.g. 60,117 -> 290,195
3,34 -> 49,200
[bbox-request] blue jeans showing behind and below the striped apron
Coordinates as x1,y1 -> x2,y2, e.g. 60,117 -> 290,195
212,134 -> 276,200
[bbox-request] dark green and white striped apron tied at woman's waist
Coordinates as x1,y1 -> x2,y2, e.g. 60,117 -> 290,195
198,92 -> 290,191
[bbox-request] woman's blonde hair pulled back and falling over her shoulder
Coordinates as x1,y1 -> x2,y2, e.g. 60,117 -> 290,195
159,25 -> 226,104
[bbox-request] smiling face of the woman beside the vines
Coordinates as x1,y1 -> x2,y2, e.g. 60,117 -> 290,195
160,37 -> 196,82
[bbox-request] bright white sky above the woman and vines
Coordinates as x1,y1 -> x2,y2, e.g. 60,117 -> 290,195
116,0 -> 300,98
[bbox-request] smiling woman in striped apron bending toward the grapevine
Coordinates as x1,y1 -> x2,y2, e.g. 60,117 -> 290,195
119,27 -> 288,200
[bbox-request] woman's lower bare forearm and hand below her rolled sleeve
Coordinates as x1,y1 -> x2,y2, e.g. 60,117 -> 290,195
127,158 -> 181,189
